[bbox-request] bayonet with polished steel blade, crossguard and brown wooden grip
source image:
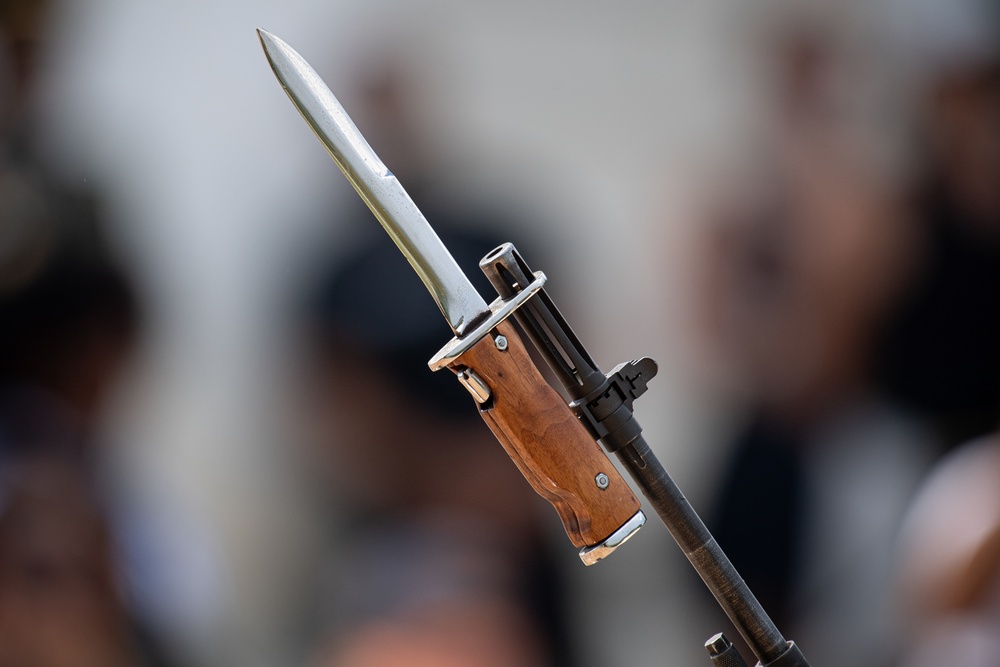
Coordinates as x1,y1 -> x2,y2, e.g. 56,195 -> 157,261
258,30 -> 646,564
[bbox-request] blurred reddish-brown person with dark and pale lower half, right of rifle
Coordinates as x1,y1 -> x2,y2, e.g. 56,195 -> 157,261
702,18 -> 928,667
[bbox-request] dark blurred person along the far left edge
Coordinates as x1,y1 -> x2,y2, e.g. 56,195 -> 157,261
0,0 -> 173,667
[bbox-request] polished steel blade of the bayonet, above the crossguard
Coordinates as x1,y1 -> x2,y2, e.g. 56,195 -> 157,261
257,29 -> 489,337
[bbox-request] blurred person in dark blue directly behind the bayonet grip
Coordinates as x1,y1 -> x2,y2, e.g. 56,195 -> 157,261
292,54 -> 572,667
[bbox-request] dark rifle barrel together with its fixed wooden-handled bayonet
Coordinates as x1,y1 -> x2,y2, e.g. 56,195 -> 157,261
257,30 -> 808,667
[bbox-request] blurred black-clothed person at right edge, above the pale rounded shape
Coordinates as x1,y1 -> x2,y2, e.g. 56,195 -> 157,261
878,35 -> 1000,446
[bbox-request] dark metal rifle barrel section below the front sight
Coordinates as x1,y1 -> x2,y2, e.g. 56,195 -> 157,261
616,435 -> 788,665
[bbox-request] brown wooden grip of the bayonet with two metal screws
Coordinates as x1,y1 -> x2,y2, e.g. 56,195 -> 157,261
450,322 -> 640,547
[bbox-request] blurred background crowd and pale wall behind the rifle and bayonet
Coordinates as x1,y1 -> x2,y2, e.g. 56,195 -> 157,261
0,0 -> 1000,667
